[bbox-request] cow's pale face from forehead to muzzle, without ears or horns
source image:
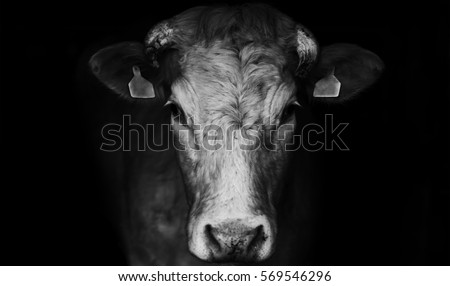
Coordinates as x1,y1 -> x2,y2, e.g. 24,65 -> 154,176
169,42 -> 297,261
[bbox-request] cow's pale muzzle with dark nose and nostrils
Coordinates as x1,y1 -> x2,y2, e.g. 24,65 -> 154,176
188,212 -> 276,263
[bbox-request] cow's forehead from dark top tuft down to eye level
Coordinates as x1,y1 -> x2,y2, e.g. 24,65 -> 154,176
163,4 -> 297,126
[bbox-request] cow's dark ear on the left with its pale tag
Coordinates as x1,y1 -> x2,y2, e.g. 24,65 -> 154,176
89,42 -> 155,98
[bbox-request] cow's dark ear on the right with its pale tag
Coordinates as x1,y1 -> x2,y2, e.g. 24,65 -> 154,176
306,44 -> 384,103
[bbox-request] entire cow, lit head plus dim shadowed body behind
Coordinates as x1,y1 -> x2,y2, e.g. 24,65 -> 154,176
89,4 -> 384,265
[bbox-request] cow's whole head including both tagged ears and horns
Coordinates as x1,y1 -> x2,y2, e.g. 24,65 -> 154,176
90,5 -> 383,261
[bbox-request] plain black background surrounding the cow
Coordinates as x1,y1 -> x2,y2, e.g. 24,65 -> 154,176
0,1 -> 450,265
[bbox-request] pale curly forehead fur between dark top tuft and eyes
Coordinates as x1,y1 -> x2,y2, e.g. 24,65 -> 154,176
172,42 -> 295,127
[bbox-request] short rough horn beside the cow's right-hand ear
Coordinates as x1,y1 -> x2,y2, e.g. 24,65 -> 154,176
296,25 -> 318,77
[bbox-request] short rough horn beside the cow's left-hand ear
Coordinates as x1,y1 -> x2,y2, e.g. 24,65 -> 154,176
145,21 -> 174,68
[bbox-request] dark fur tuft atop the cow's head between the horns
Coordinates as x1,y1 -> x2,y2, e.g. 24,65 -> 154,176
170,4 -> 297,50
